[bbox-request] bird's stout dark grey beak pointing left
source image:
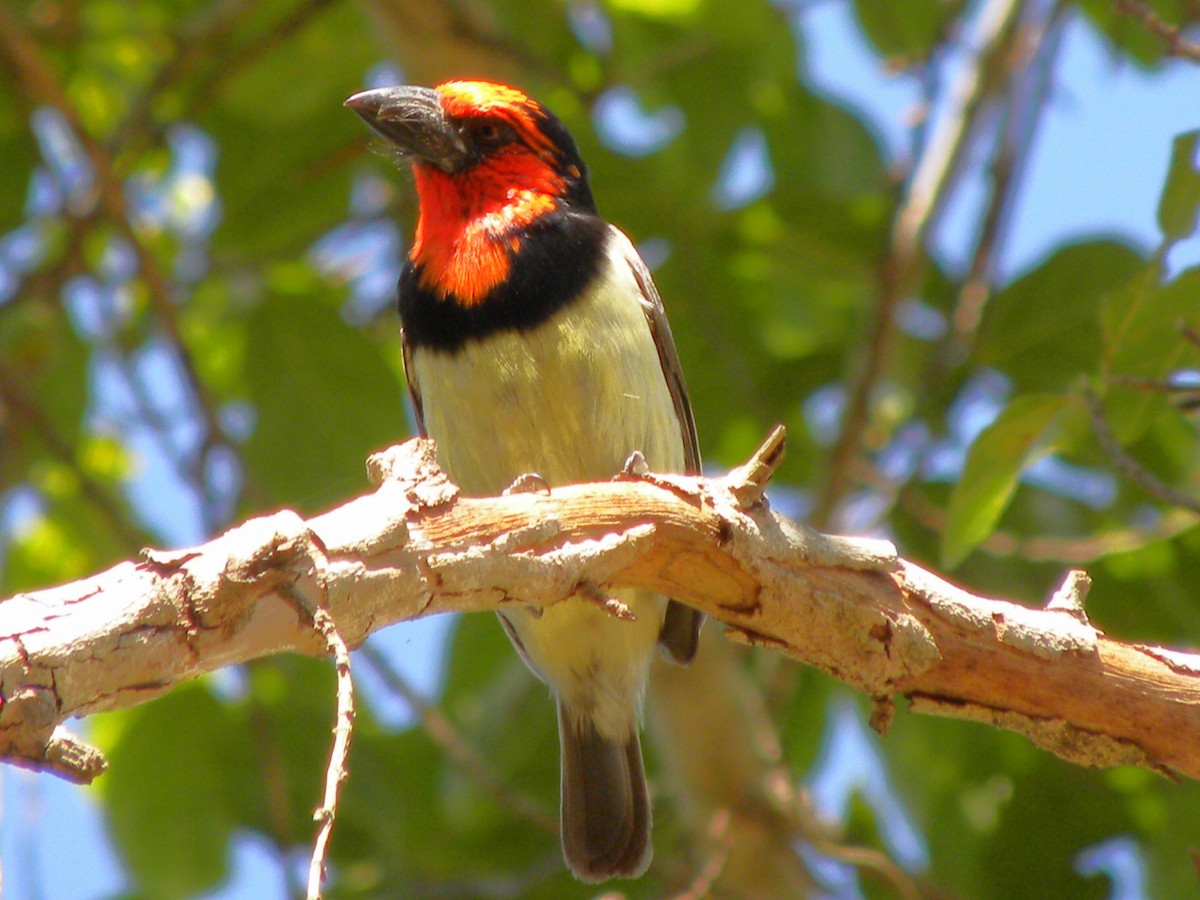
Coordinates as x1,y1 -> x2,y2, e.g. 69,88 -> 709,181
344,85 -> 470,172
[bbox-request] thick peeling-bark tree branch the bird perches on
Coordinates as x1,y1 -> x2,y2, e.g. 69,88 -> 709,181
0,440 -> 1200,779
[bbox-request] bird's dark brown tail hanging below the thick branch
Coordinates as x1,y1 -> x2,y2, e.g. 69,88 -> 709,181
558,702 -> 652,883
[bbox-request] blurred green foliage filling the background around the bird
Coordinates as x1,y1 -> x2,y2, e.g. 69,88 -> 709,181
0,0 -> 1200,898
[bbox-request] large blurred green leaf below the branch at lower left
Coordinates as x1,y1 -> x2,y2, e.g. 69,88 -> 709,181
97,682 -> 253,898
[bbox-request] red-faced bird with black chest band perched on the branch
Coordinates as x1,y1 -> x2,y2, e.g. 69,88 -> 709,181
346,80 -> 703,883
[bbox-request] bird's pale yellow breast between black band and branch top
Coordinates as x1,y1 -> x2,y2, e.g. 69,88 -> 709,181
413,225 -> 684,494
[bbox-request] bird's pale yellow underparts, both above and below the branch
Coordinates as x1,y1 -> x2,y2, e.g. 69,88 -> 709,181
412,232 -> 684,738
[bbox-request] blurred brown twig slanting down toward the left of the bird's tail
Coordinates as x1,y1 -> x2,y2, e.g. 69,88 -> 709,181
358,642 -> 558,834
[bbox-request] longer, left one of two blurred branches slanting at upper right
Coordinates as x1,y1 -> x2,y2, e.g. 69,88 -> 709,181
812,0 -> 1021,527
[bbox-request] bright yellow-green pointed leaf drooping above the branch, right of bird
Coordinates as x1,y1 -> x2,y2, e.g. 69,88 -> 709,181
942,394 -> 1072,568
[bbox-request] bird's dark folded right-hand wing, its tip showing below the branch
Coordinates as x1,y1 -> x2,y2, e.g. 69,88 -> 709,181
614,229 -> 704,665
